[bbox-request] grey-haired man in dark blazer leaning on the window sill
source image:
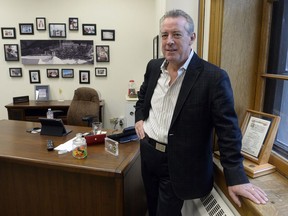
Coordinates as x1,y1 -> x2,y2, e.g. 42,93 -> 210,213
135,10 -> 268,216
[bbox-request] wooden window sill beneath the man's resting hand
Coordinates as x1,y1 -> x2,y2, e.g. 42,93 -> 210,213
214,157 -> 288,216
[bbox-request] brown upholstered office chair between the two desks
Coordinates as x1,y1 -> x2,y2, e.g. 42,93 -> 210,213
67,87 -> 100,127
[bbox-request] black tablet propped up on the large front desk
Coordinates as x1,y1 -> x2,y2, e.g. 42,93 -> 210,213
39,118 -> 72,136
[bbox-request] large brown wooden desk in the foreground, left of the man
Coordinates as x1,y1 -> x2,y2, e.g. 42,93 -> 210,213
0,120 -> 146,216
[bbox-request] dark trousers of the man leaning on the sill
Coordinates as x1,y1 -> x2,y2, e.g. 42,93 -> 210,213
140,137 -> 184,216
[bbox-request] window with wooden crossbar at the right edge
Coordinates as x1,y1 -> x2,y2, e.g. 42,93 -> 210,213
263,0 -> 288,159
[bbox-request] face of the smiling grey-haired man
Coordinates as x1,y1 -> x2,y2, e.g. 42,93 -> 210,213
160,17 -> 195,65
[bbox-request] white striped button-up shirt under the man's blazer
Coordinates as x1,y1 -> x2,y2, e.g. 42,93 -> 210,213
143,50 -> 194,143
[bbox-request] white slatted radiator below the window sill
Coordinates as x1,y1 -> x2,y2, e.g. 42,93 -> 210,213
182,188 -> 239,216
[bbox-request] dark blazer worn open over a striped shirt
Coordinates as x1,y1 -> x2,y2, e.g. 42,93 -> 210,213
135,53 -> 248,199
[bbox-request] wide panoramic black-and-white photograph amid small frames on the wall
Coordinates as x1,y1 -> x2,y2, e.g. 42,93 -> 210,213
20,40 -> 94,65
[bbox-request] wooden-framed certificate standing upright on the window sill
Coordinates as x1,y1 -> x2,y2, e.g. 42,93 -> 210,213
241,109 -> 280,165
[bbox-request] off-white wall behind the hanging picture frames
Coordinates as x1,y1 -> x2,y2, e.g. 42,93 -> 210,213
0,0 -> 157,127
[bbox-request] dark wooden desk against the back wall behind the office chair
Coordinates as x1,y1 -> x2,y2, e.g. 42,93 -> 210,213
5,100 -> 104,123
